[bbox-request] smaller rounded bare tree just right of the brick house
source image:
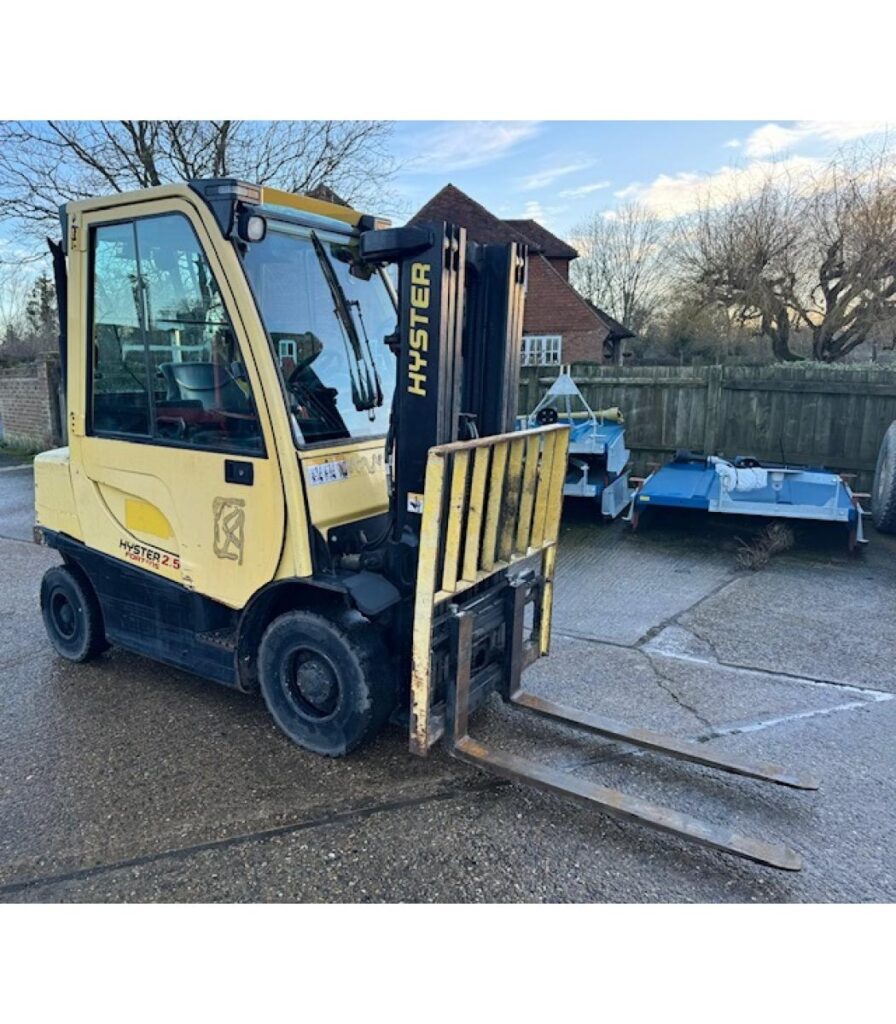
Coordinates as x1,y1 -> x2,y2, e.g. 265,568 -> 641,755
570,203 -> 668,344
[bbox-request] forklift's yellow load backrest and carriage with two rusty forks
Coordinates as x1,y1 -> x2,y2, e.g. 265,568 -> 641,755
410,425 -> 817,870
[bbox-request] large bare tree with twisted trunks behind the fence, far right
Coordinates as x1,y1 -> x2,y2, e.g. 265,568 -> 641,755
675,142 -> 896,362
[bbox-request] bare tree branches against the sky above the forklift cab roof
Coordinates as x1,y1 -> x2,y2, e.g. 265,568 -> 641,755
0,121 -> 394,258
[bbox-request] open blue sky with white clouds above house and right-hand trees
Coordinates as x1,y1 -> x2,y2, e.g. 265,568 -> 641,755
382,121 -> 886,237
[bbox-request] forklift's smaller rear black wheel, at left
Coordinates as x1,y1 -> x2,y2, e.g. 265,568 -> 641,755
41,565 -> 109,662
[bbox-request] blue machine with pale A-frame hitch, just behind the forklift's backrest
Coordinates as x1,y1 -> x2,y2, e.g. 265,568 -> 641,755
516,370 -> 632,519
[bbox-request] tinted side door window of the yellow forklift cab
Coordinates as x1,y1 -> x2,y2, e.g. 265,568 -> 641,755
91,214 -> 263,454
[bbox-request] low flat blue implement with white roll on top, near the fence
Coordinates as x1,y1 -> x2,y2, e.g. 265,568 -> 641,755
629,452 -> 866,549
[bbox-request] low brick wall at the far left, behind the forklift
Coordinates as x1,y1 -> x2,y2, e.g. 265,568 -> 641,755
0,356 -> 61,447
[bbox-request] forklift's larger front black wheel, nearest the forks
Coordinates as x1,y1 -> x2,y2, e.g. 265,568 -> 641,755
258,610 -> 396,757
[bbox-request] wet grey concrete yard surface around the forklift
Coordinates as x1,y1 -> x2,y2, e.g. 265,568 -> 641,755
0,466 -> 896,902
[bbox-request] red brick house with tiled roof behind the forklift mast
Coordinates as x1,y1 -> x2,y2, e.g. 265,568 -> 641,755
411,184 -> 634,366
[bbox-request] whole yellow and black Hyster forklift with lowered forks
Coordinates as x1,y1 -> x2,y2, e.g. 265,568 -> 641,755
35,179 -> 814,870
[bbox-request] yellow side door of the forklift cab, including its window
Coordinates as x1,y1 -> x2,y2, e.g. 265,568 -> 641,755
37,192 -> 292,608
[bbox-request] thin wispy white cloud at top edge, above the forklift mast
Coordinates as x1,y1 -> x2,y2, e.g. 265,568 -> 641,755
404,121 -> 539,173
